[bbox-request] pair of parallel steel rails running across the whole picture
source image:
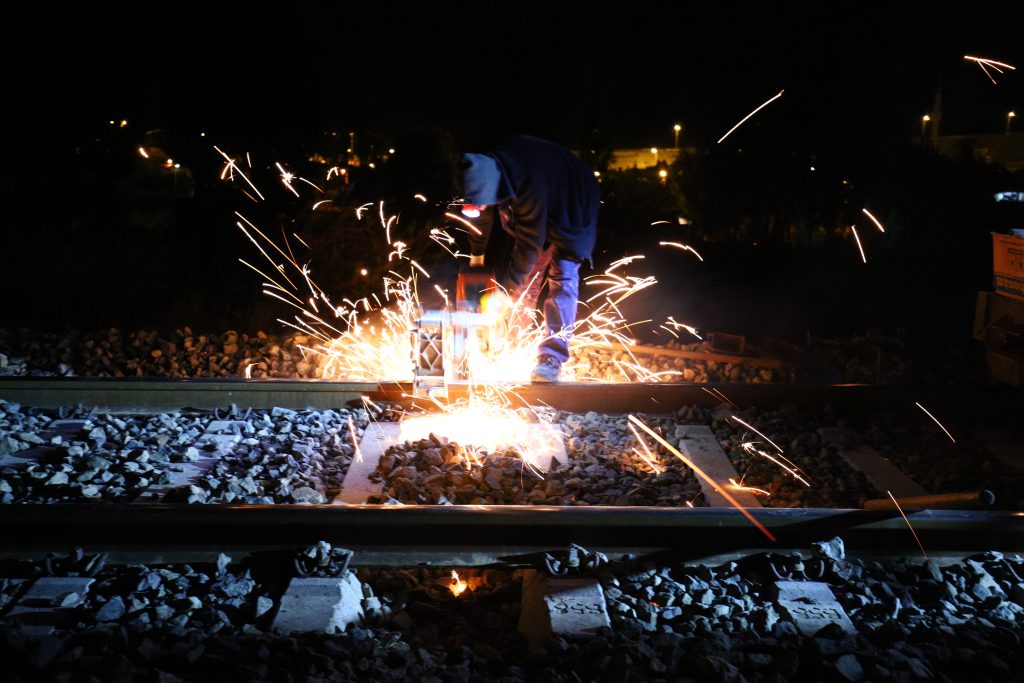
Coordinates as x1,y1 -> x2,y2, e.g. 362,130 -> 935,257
0,378 -> 1024,564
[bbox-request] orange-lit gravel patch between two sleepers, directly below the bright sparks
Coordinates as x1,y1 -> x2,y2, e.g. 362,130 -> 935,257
370,412 -> 701,507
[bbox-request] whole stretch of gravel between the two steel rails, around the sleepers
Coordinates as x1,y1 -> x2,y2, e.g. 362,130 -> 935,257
0,400 -> 1024,510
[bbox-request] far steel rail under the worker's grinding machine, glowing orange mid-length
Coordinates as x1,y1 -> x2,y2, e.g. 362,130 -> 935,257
0,378 -> 1024,417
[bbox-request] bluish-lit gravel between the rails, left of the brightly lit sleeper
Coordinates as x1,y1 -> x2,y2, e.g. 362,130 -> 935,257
0,400 -> 369,504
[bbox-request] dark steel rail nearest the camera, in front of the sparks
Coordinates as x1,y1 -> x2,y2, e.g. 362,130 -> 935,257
0,505 -> 1024,557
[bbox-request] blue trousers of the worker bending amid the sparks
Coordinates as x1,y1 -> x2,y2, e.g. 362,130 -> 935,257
513,245 -> 580,362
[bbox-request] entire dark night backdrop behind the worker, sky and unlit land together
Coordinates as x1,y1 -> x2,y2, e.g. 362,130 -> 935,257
0,2 -> 1024,342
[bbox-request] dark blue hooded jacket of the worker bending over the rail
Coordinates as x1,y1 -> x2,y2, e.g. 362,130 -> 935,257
463,135 -> 600,261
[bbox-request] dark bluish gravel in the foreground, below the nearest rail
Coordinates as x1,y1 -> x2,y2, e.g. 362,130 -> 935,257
0,539 -> 1024,683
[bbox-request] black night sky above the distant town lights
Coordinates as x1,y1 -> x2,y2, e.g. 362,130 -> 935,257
12,1 -> 1024,153
